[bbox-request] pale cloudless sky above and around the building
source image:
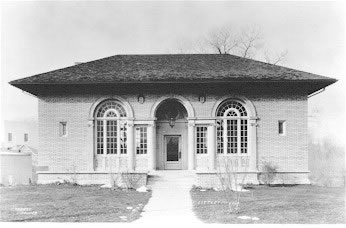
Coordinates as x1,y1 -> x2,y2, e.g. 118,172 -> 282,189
0,1 -> 346,146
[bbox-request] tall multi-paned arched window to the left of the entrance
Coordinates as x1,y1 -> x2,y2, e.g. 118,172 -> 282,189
95,100 -> 127,155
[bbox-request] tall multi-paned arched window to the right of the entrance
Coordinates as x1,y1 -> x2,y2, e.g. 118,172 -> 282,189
216,100 -> 249,155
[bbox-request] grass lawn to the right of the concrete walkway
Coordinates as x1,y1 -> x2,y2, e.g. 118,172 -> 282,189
191,185 -> 345,224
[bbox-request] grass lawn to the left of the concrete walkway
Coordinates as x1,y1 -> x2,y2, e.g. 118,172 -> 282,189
0,185 -> 151,222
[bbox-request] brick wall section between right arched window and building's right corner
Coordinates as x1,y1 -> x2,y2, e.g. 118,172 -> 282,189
251,93 -> 308,171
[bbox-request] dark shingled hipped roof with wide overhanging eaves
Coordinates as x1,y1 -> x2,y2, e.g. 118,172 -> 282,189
10,54 -> 336,94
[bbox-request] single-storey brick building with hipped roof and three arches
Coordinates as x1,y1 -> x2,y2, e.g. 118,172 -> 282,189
10,55 -> 336,186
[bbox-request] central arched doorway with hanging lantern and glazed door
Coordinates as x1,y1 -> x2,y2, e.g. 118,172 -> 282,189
155,98 -> 188,170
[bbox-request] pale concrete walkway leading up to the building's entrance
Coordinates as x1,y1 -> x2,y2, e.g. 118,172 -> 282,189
135,170 -> 202,225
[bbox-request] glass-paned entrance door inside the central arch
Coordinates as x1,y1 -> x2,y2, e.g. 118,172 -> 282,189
165,135 -> 181,169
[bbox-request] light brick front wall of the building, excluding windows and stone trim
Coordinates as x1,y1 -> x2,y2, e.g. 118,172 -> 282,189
38,91 -> 308,184
